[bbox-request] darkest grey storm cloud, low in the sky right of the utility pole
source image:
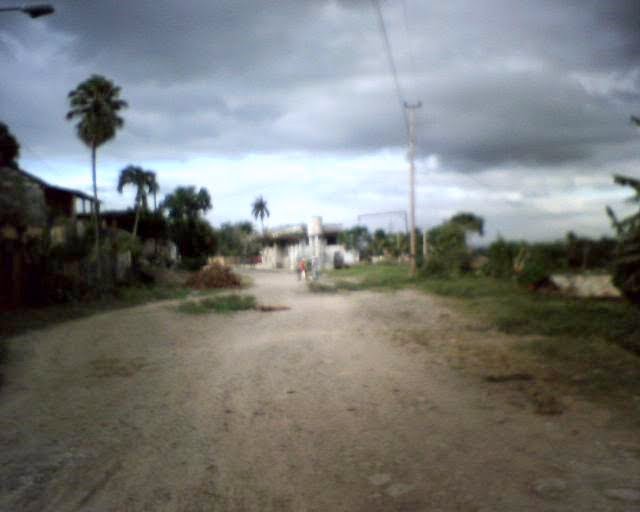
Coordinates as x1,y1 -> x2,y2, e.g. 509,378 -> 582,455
422,71 -> 637,167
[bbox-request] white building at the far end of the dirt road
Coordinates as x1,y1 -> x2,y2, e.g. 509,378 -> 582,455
260,217 -> 359,270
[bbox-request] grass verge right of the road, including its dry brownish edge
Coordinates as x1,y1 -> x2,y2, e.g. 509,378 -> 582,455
330,265 -> 640,412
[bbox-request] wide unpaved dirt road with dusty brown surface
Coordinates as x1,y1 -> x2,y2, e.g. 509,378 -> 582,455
0,272 -> 640,512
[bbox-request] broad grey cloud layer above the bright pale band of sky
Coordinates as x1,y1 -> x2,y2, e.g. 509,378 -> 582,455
0,0 -> 640,170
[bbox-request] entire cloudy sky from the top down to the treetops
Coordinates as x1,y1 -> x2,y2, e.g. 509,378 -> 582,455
0,0 -> 640,240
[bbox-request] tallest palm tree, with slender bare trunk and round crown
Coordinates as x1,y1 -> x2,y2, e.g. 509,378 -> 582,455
67,75 -> 127,281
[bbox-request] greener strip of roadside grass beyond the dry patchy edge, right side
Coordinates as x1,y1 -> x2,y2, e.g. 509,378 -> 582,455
325,265 -> 640,355
